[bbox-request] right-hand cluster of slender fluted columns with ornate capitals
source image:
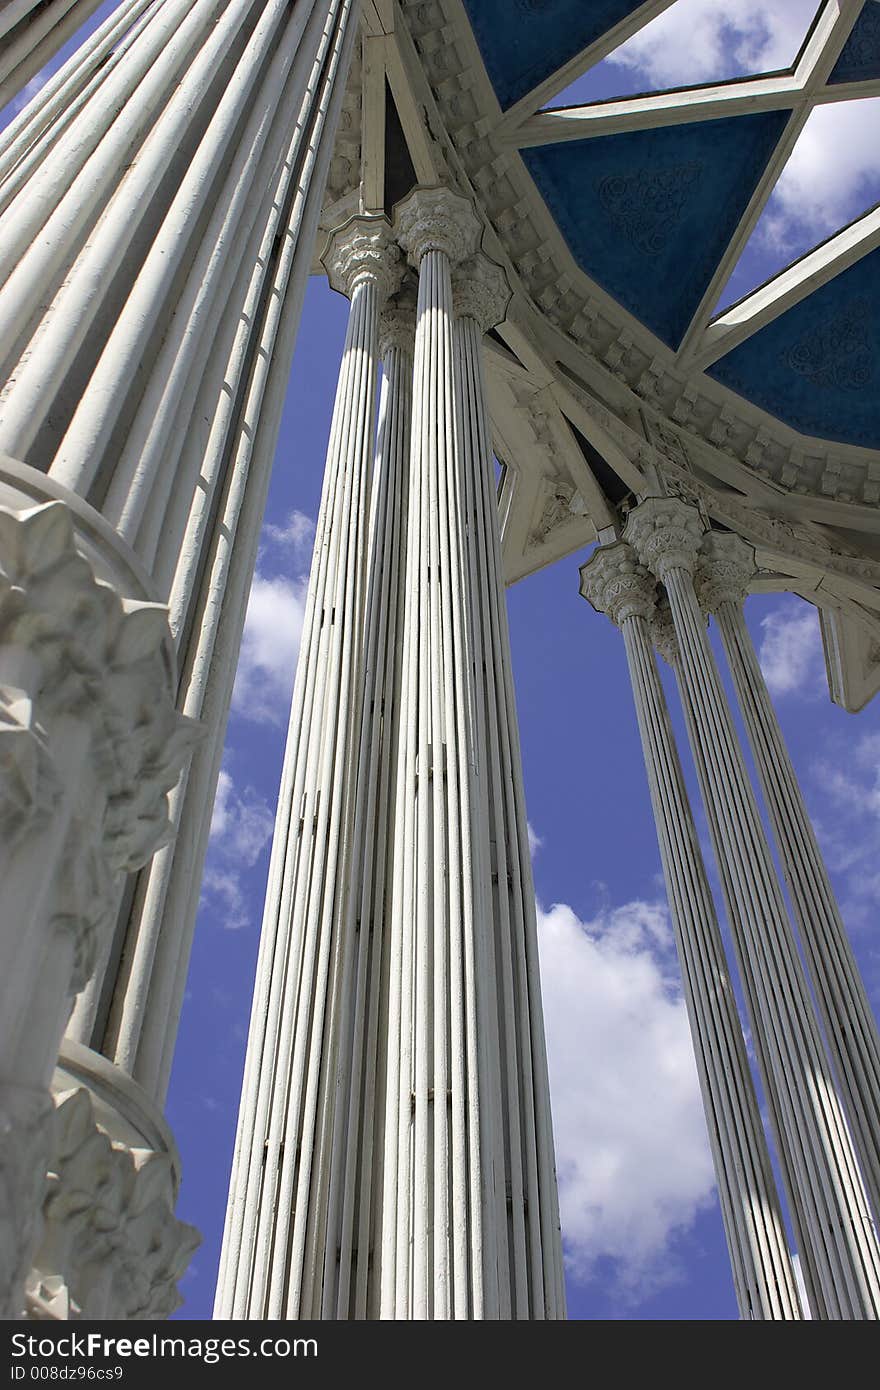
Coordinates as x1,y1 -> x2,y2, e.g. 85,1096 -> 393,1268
581,498 -> 880,1319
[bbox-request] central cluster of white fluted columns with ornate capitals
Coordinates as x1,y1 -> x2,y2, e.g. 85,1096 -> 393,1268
217,189 -> 564,1319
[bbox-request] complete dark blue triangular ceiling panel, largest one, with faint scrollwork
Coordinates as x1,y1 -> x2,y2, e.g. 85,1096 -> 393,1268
523,111 -> 788,348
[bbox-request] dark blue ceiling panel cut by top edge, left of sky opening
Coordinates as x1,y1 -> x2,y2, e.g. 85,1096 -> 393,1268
464,0 -> 642,110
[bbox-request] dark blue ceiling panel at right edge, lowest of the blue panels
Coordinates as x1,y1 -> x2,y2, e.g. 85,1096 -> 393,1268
709,250 -> 880,449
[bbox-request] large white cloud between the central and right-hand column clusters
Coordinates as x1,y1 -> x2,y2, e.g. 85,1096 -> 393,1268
538,902 -> 715,1301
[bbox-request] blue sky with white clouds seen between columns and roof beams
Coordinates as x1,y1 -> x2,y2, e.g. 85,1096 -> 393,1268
5,0 -> 880,1321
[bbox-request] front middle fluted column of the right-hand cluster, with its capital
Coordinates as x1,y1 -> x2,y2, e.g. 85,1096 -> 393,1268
624,498 -> 880,1319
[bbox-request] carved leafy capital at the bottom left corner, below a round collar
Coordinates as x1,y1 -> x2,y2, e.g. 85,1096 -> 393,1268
26,1088 -> 200,1319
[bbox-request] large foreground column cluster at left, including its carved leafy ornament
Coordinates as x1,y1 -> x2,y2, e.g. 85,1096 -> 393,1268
0,0 -> 359,1316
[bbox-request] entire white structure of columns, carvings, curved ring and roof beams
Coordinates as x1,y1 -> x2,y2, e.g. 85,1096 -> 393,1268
0,0 -> 880,1321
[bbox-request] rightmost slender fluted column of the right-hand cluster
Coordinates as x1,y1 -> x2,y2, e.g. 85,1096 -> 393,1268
696,532 -> 880,1219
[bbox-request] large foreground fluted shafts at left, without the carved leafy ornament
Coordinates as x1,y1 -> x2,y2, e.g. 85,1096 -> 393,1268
0,0 -> 359,1307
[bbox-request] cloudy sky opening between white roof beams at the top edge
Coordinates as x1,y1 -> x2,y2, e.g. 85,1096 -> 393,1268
546,0 -> 817,111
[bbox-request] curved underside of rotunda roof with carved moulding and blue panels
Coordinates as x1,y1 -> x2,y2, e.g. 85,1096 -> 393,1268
324,0 -> 880,708
